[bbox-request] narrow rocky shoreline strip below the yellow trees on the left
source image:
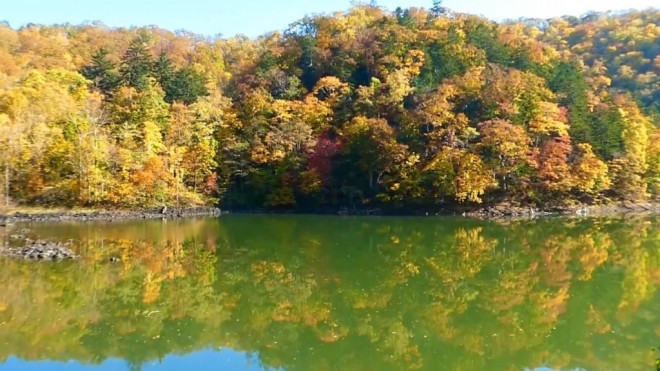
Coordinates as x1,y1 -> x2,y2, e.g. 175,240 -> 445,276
0,207 -> 222,226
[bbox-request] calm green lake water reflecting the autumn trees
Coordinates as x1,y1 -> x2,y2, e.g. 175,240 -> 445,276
0,216 -> 660,371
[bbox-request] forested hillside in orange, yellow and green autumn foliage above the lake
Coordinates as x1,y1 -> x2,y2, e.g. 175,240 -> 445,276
0,5 -> 660,210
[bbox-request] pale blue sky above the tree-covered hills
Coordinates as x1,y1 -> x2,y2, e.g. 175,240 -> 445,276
0,0 -> 660,37
